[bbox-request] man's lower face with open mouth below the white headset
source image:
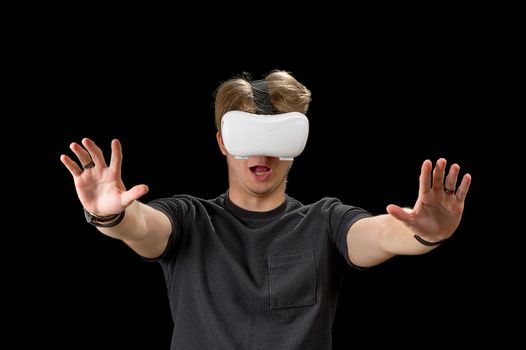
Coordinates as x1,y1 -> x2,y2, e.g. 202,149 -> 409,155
218,134 -> 292,197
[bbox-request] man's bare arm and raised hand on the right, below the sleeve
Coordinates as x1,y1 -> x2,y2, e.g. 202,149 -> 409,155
347,158 -> 471,267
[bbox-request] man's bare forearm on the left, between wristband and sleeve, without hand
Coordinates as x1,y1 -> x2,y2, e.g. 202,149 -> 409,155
97,201 -> 172,258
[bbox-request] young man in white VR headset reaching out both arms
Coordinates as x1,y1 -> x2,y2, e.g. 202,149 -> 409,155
61,71 -> 471,350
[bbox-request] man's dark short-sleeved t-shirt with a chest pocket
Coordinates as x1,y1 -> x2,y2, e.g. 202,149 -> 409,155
149,193 -> 370,350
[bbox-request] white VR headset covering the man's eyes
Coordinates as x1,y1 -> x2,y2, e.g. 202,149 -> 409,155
221,111 -> 309,160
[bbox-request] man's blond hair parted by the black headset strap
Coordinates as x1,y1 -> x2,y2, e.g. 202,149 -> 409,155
214,70 -> 311,130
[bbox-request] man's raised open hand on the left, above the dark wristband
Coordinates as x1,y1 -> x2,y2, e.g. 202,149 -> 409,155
60,138 -> 148,216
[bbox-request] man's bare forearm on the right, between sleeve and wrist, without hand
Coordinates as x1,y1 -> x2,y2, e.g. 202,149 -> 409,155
347,214 -> 436,267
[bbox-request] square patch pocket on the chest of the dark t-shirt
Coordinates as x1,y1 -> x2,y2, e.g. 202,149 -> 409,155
268,251 -> 316,309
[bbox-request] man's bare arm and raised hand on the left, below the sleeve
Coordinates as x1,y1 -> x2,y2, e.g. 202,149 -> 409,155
60,138 -> 172,258
